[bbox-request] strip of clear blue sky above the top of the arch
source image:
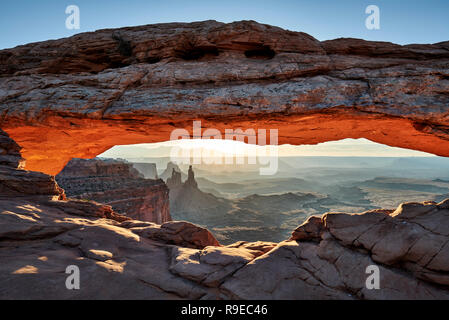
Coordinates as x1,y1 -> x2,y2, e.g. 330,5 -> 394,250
0,0 -> 449,48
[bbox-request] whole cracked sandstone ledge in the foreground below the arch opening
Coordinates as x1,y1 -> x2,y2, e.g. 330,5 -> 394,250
0,131 -> 449,300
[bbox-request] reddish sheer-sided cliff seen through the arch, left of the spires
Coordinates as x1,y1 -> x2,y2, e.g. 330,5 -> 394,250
56,159 -> 171,224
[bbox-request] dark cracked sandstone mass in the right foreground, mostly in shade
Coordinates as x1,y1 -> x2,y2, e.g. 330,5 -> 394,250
221,200 -> 449,299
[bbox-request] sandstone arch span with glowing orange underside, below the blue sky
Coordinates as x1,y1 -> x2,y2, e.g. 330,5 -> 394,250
0,21 -> 449,175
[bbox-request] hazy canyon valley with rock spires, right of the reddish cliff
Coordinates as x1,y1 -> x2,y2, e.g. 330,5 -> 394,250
164,157 -> 449,245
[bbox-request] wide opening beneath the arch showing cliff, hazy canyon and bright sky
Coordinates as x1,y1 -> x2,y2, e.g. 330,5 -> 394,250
56,139 -> 449,244
